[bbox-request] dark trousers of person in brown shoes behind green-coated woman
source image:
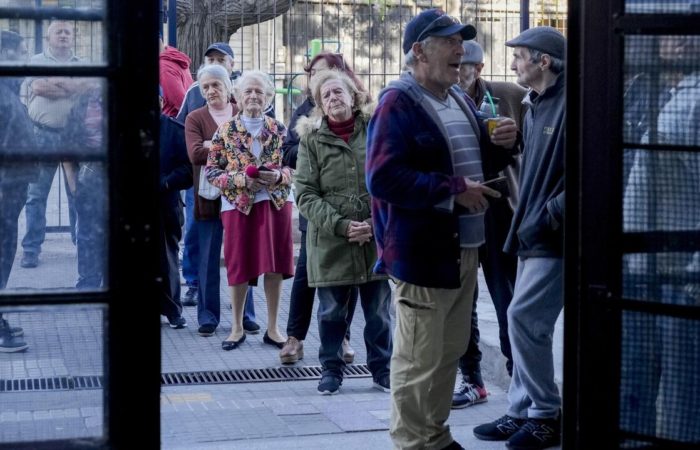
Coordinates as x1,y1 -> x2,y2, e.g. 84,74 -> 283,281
287,230 -> 357,341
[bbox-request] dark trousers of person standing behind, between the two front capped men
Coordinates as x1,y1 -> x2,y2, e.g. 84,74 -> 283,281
459,201 -> 518,386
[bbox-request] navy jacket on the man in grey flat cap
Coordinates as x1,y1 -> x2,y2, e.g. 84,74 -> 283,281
503,72 -> 566,258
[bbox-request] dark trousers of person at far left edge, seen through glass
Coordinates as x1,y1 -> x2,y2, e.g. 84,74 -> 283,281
0,180 -> 29,288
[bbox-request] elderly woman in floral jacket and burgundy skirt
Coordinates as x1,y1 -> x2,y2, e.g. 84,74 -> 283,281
206,71 -> 294,350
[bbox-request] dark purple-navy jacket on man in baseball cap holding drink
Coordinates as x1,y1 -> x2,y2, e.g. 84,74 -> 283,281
365,74 -> 512,289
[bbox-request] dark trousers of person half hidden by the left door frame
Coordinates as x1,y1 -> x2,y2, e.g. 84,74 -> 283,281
160,206 -> 184,318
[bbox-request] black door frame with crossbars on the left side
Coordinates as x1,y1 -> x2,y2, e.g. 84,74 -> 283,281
0,0 -> 160,449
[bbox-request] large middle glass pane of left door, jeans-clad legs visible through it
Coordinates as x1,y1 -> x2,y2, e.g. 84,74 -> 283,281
0,77 -> 108,290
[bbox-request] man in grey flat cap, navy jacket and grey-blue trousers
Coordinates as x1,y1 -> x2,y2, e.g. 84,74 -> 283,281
474,27 -> 566,450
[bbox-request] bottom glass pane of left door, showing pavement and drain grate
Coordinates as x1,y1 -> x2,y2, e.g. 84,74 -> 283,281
0,306 -> 106,443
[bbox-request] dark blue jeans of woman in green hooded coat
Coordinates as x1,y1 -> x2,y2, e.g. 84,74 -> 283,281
316,280 -> 392,380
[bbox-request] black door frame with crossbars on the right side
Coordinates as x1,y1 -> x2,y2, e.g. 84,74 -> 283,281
563,0 -> 700,450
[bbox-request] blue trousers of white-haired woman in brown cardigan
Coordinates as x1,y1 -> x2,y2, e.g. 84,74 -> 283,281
196,219 -> 255,327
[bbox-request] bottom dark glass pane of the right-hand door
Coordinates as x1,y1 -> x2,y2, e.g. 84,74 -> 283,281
620,312 -> 700,442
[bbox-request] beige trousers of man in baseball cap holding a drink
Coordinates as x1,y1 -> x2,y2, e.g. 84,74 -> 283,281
389,249 -> 478,450
